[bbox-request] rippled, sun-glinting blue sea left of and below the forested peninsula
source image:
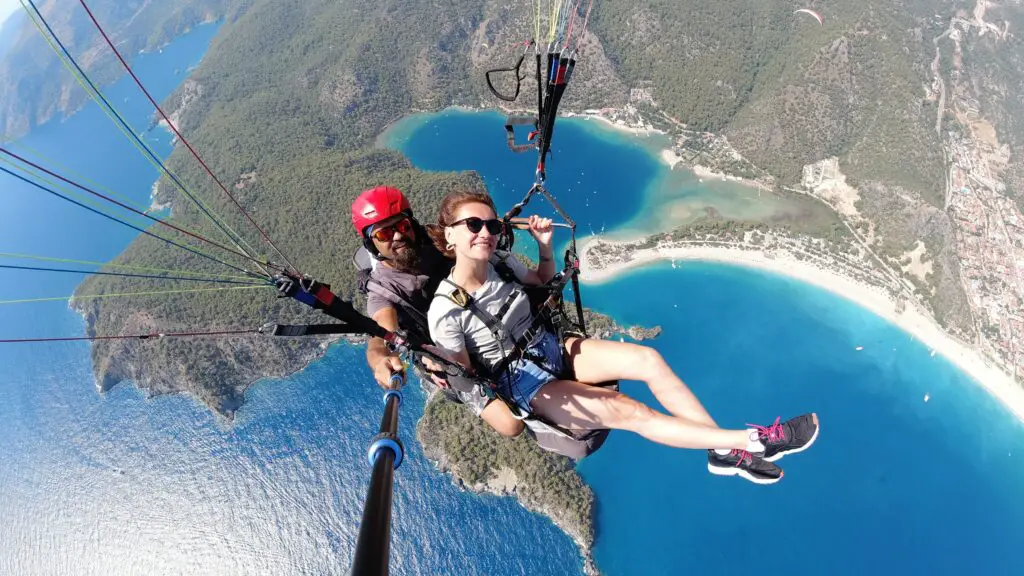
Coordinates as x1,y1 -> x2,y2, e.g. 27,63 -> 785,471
0,27 -> 582,575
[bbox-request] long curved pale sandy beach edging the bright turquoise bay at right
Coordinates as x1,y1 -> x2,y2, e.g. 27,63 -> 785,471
580,238 -> 1024,420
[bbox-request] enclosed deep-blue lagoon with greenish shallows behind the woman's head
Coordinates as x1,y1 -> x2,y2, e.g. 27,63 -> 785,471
378,109 -> 801,237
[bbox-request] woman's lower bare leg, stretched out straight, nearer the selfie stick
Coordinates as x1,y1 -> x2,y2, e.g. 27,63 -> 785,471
531,380 -> 750,450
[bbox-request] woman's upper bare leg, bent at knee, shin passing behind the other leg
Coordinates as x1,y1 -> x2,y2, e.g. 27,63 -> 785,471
565,338 -> 718,427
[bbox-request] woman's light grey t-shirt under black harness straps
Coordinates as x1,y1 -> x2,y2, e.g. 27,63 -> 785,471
427,252 -> 532,366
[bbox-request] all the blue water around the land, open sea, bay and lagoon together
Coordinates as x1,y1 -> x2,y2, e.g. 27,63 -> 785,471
0,25 -> 1024,575
